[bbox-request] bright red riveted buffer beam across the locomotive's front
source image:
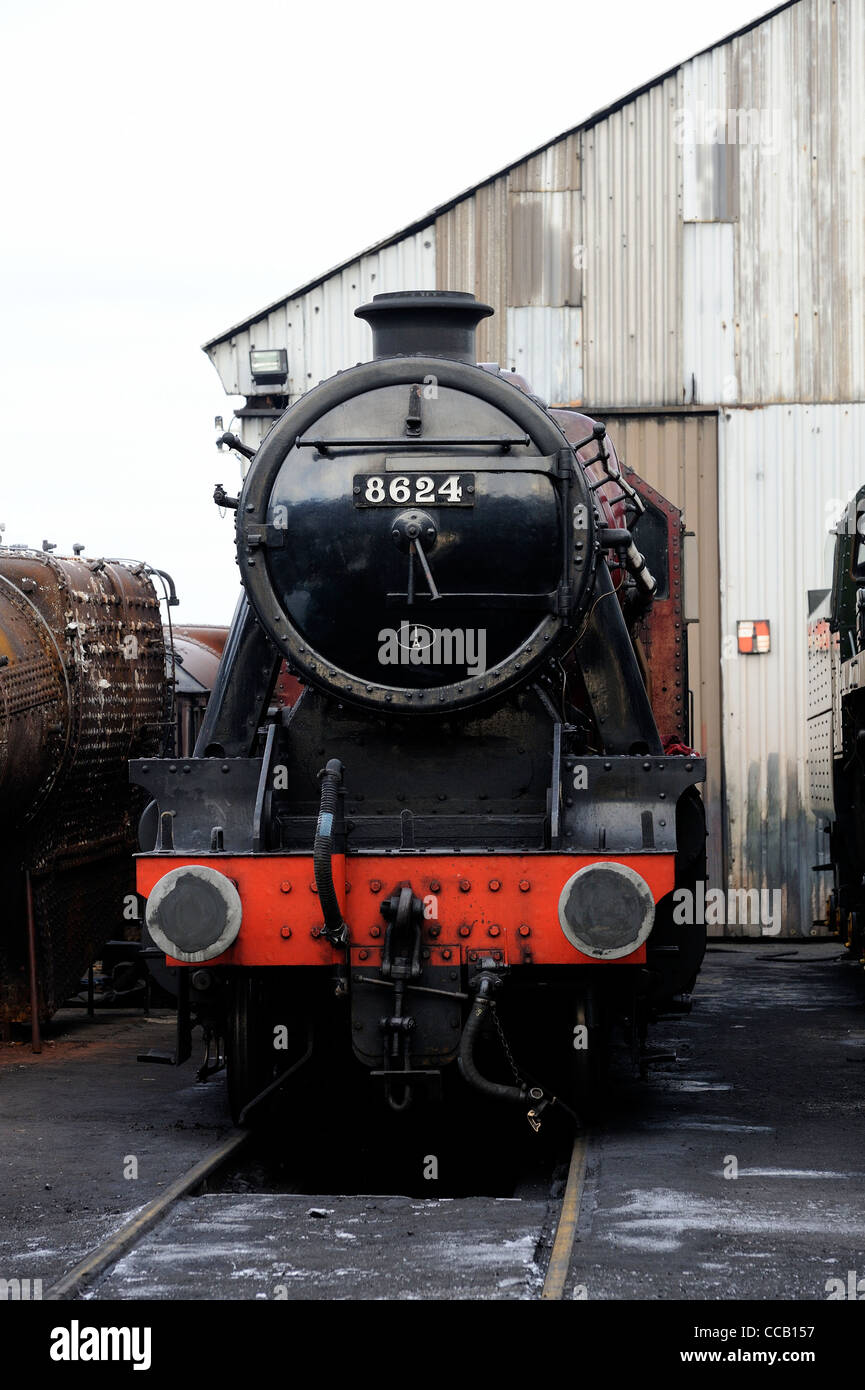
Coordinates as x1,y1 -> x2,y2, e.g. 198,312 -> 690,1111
136,853 -> 674,969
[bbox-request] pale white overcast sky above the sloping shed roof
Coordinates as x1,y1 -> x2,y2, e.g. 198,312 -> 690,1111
0,0 -> 770,623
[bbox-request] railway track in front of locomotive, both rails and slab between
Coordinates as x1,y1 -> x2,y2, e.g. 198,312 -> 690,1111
45,1130 -> 587,1301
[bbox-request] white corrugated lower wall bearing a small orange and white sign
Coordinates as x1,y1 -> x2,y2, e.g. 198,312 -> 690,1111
719,403 -> 865,935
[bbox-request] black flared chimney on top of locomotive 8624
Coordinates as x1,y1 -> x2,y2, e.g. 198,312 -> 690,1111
355,289 -> 494,364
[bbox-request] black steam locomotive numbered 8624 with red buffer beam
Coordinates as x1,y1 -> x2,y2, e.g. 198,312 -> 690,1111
131,291 -> 705,1129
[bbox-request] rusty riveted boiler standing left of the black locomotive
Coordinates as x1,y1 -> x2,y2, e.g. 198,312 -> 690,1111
0,548 -> 170,1027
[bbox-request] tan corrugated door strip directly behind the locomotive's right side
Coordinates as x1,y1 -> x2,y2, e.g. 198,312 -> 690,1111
604,413 -> 726,887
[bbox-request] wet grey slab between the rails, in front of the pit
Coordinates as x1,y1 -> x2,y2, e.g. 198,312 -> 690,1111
86,1193 -> 547,1300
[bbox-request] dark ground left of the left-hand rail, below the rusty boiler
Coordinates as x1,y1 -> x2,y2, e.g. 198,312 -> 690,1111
0,1009 -> 231,1289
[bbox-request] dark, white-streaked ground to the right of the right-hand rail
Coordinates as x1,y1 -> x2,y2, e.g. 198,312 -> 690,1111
569,942 -> 865,1300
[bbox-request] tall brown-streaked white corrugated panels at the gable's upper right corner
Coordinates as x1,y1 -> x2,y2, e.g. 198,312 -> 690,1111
729,0 -> 865,403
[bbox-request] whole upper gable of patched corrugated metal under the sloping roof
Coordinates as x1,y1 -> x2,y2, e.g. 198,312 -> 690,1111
210,0 -> 865,407
